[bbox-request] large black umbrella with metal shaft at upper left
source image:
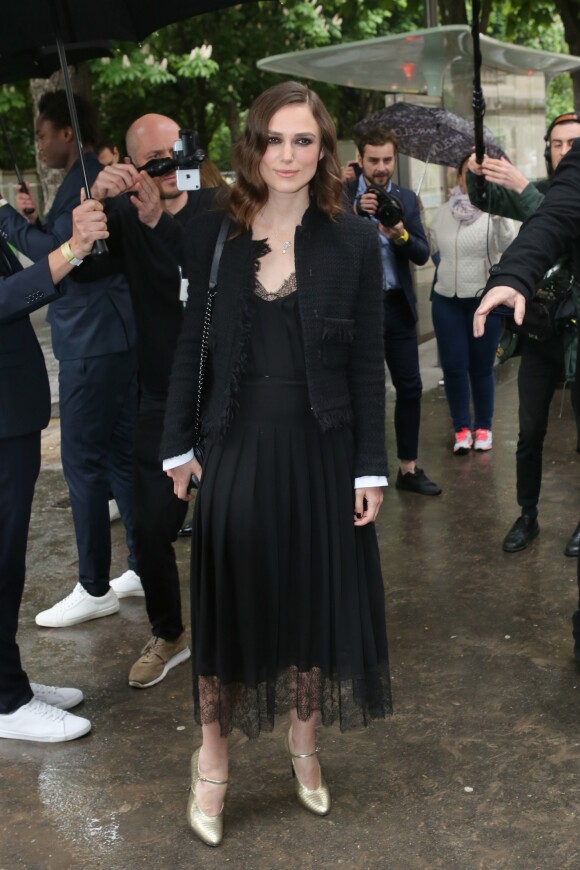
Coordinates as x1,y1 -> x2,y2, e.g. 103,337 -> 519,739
0,0 -> 258,252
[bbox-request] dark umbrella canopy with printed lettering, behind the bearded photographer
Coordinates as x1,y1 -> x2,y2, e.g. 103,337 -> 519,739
355,103 -> 506,167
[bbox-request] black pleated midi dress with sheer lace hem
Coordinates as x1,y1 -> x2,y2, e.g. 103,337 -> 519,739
191,276 -> 391,737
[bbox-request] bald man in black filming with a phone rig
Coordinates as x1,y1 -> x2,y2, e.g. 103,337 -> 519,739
86,114 -> 222,689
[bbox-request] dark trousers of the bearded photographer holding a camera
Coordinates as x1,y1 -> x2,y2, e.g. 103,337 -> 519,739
384,289 -> 423,460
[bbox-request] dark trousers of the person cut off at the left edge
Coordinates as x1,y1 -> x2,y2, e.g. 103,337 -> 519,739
0,432 -> 40,714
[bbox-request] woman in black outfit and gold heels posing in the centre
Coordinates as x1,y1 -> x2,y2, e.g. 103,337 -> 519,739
163,82 -> 391,845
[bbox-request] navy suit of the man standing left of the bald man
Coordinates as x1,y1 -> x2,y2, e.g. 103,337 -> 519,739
0,153 -> 137,595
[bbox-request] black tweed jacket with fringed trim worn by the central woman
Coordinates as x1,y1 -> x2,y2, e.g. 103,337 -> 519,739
161,206 -> 387,477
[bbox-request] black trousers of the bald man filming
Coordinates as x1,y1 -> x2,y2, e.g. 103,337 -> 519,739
133,413 -> 188,640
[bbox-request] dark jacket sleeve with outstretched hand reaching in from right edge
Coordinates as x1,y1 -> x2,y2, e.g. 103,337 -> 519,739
486,139 -> 580,299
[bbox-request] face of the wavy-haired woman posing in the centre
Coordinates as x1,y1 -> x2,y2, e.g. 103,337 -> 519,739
260,103 -> 323,194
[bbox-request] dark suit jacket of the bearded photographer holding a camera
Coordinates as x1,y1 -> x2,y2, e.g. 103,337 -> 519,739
344,179 -> 429,322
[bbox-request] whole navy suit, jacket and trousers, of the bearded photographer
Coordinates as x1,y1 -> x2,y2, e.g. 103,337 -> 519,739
345,180 -> 429,460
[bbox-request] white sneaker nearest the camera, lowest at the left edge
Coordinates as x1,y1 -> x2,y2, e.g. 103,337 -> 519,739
0,698 -> 91,743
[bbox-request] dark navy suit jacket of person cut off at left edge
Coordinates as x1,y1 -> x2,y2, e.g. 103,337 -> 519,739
0,238 -> 57,438
